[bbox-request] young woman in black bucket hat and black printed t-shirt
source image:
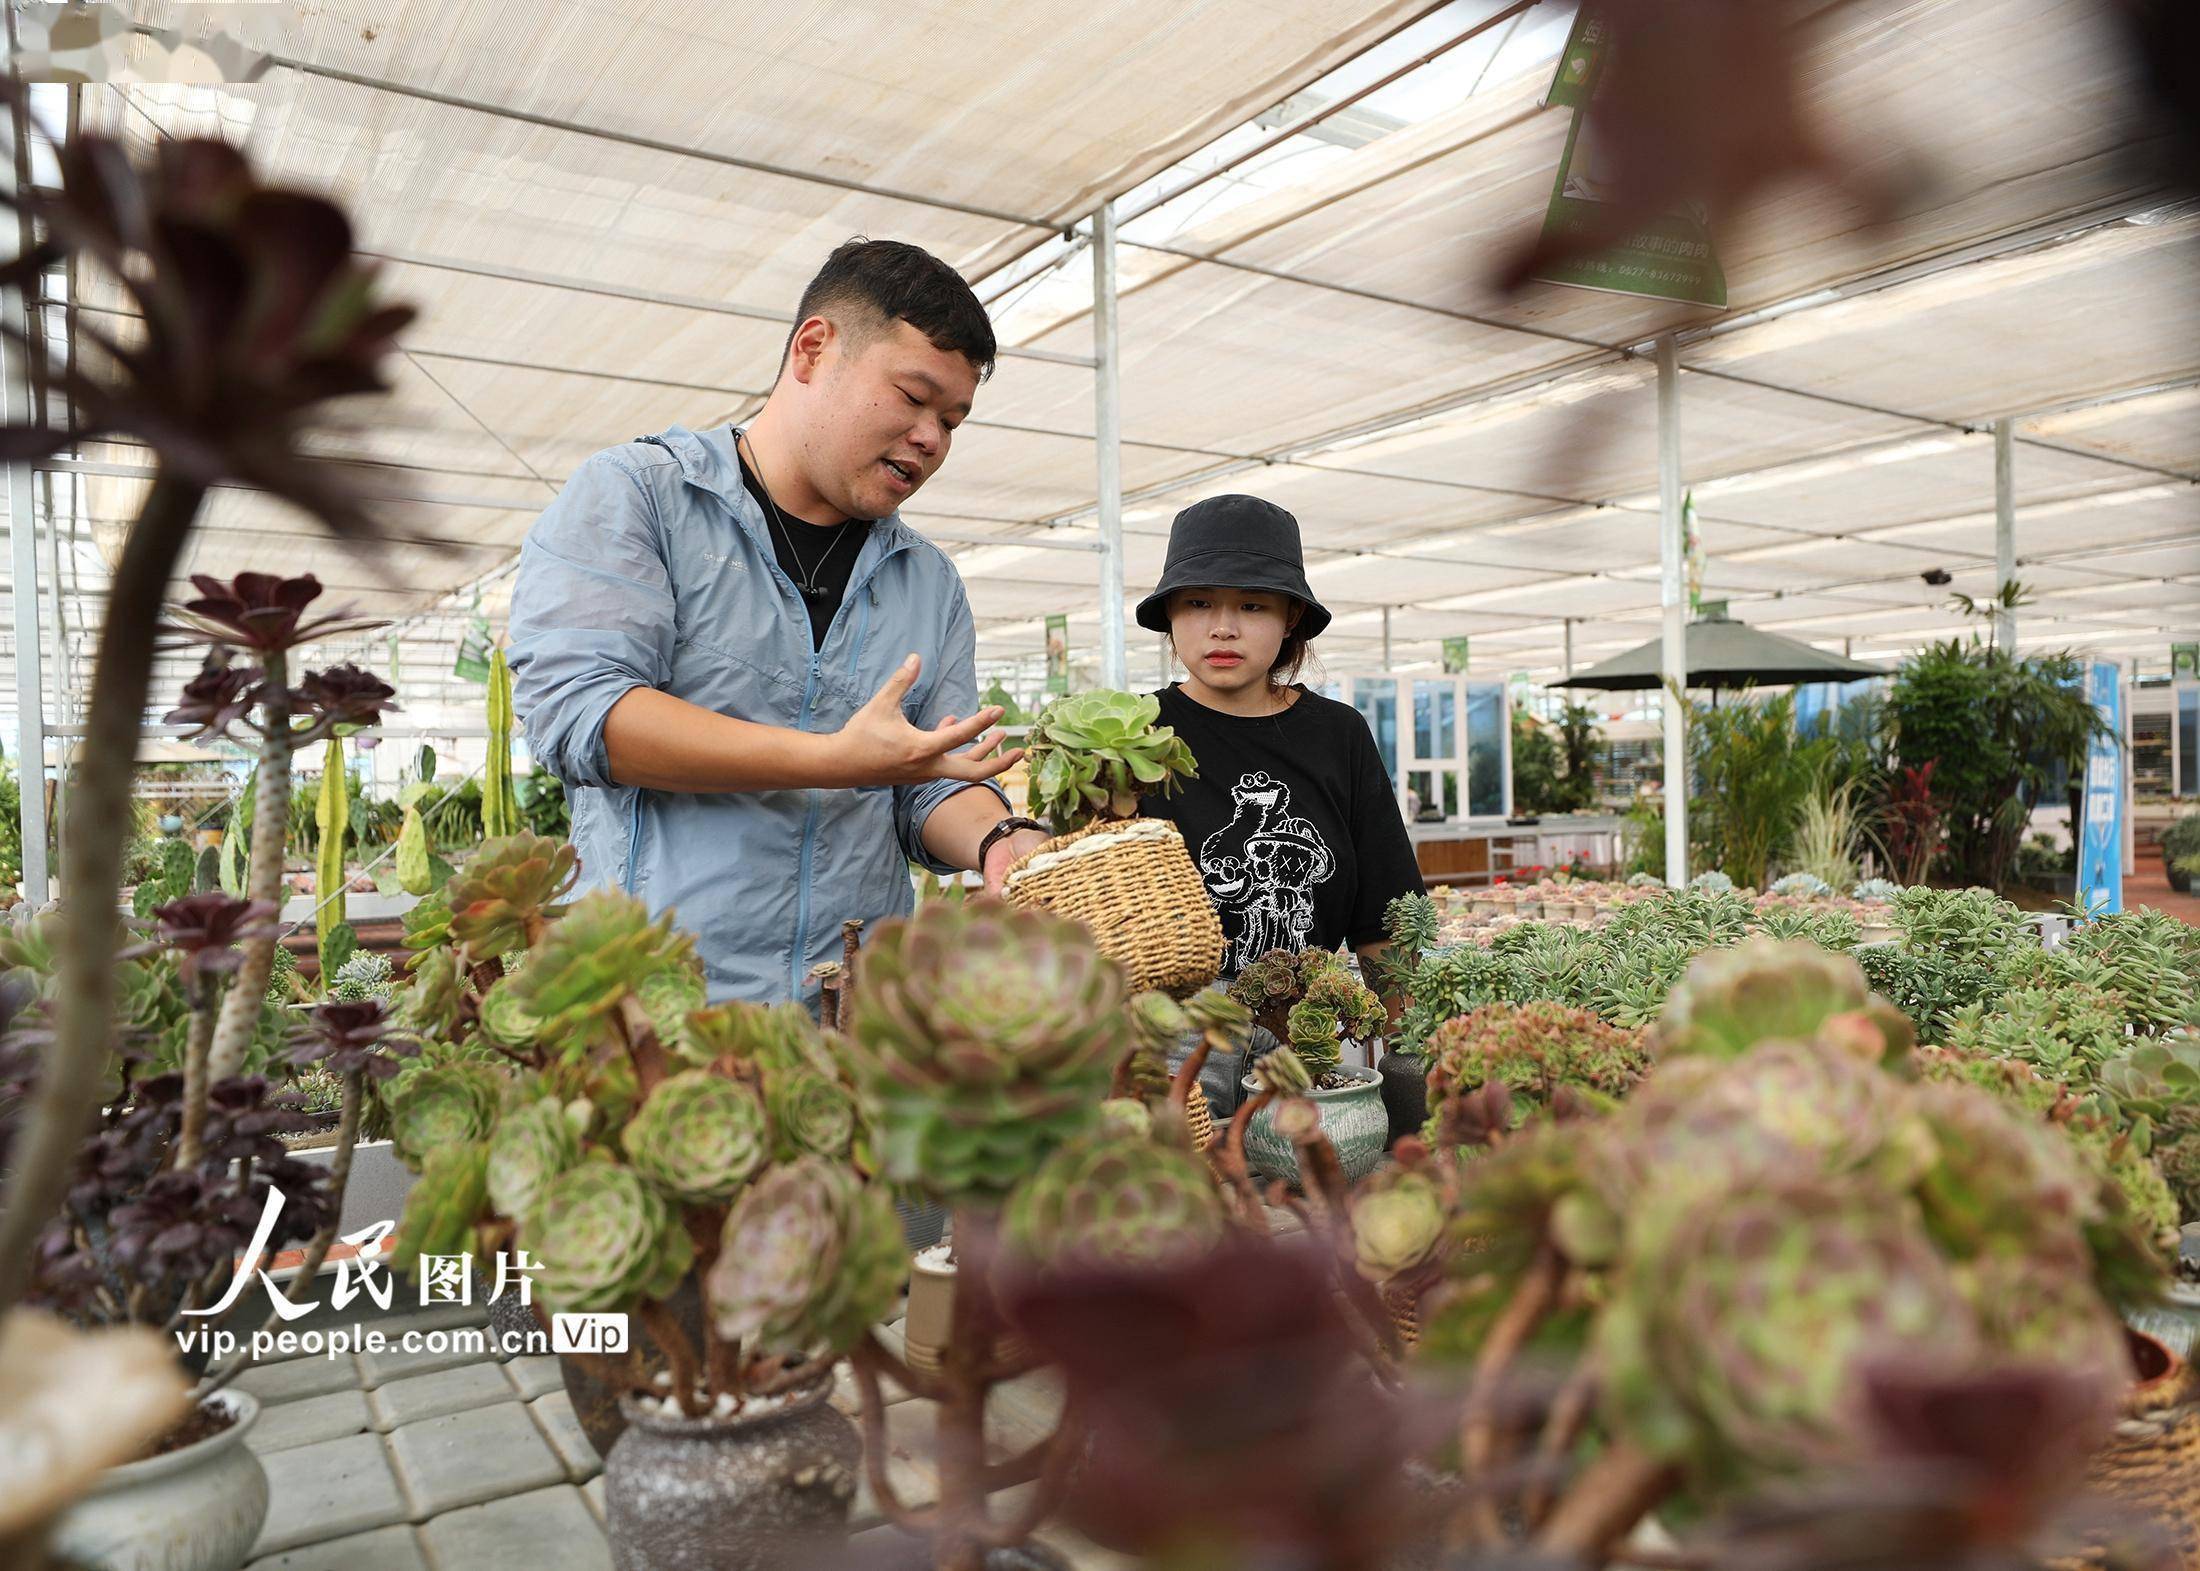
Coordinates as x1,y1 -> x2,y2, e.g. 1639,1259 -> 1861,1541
1137,495 -> 1423,977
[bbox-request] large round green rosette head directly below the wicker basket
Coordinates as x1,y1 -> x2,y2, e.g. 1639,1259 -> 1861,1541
849,902 -> 1124,1197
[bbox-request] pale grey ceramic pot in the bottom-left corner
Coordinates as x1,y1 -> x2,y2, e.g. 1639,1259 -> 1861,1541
53,1388 -> 268,1571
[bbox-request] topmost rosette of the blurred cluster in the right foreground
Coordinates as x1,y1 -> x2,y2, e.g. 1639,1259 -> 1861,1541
1657,937 -> 1870,1058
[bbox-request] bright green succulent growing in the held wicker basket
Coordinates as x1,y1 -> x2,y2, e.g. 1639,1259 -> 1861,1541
1025,689 -> 1199,834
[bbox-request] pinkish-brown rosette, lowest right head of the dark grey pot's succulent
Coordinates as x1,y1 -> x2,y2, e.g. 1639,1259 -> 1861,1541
704,1157 -> 909,1358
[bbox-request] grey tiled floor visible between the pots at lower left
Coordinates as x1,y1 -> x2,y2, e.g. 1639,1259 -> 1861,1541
238,1309 -> 1133,1571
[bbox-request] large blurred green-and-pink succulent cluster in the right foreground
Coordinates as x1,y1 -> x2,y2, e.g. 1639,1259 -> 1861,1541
1355,942 -> 2160,1564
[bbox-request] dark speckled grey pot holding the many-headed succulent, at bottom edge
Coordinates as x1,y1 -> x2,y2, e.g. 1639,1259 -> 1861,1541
603,1380 -> 862,1571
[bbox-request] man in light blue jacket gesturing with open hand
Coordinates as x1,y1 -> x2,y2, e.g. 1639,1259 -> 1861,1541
510,240 -> 1045,1001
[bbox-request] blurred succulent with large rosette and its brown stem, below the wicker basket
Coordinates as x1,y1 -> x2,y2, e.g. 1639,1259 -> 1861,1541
831,902 -> 1126,1571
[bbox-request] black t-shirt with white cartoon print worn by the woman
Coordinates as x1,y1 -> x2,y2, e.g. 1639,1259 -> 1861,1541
1140,686 -> 1426,975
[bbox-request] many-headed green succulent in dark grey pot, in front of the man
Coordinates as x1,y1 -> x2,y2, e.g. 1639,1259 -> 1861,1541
387,858 -> 906,1571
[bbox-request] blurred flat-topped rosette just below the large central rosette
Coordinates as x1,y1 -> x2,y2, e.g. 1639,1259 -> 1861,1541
1003,1129 -> 1223,1267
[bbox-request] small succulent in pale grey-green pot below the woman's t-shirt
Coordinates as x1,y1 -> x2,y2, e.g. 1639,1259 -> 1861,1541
1230,948 -> 1390,1182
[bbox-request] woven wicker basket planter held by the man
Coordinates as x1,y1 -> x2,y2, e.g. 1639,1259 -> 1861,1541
1003,819 -> 1223,999
